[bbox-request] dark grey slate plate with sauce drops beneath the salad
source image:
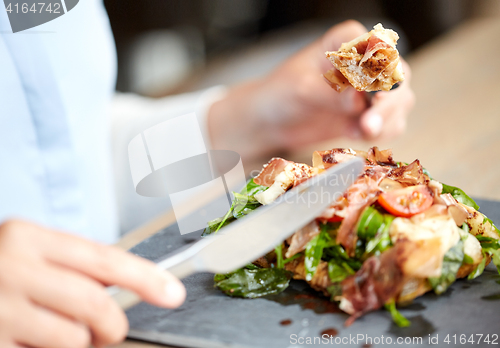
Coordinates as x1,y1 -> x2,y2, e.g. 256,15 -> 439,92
127,199 -> 500,348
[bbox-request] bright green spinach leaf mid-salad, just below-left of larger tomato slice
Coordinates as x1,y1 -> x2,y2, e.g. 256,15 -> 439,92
357,206 -> 394,255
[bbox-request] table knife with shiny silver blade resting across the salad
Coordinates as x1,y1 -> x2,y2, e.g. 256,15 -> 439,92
107,158 -> 364,309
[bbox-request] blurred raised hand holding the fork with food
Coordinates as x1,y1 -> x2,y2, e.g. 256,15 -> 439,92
209,21 -> 414,158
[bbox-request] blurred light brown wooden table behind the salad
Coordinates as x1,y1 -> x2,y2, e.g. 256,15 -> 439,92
111,18 -> 500,348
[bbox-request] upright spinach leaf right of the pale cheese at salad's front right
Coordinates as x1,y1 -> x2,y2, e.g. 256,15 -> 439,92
429,240 -> 464,295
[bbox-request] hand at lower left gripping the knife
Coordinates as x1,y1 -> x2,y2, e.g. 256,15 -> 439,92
0,220 -> 186,348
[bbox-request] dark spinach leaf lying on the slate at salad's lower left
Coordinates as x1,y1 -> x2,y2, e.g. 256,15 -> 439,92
214,267 -> 292,298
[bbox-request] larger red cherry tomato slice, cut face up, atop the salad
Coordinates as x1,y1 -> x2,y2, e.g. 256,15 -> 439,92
378,185 -> 433,217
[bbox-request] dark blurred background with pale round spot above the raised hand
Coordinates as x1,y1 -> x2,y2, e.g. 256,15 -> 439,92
104,0 -> 500,97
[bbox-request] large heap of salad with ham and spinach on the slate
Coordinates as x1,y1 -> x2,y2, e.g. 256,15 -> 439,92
204,147 -> 500,326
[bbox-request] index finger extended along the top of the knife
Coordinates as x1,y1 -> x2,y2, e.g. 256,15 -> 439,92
25,222 -> 186,308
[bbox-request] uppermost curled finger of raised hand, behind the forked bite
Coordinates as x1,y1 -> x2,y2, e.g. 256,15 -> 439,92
319,20 -> 367,73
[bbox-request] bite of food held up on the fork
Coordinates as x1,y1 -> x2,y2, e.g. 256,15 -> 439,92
324,23 -> 404,92
